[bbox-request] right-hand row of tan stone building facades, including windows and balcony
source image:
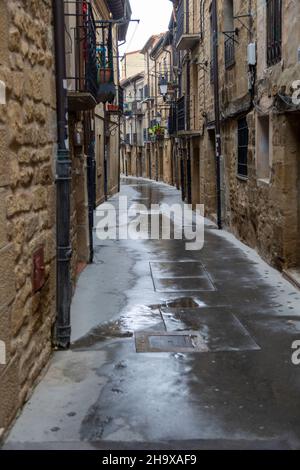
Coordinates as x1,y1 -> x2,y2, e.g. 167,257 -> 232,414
172,0 -> 300,282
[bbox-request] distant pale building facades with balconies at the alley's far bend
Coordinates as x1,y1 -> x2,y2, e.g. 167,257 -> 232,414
121,32 -> 175,184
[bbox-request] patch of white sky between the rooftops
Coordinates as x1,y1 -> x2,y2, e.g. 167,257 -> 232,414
120,0 -> 173,54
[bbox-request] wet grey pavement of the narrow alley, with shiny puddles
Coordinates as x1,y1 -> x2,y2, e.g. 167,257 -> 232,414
6,179 -> 300,449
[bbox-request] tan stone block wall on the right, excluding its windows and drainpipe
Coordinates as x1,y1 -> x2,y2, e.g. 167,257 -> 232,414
181,0 -> 300,269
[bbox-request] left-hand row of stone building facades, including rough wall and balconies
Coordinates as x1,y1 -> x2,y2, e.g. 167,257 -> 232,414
0,0 -> 131,438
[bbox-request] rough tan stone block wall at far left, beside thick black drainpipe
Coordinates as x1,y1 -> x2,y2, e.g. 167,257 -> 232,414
0,0 -> 56,433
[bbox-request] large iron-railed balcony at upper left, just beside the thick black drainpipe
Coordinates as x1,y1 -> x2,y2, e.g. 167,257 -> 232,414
64,0 -> 116,111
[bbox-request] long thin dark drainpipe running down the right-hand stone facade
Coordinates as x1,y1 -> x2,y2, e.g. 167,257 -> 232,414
212,0 -> 222,230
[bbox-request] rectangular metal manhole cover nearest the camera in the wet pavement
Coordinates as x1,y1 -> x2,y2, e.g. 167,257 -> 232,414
135,331 -> 208,353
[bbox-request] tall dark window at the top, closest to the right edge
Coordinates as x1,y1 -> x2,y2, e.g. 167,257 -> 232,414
267,0 -> 282,66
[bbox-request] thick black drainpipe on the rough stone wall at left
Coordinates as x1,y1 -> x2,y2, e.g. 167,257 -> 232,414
53,0 -> 72,349
